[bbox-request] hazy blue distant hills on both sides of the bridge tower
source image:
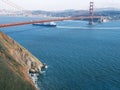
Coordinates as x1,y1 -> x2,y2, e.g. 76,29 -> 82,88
32,8 -> 120,19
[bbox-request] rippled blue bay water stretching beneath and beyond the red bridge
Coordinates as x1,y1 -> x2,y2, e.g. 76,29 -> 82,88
0,17 -> 120,90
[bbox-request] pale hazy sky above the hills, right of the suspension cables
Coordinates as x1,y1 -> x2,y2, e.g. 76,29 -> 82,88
8,0 -> 120,11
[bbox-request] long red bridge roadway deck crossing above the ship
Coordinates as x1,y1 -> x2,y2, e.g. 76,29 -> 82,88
0,16 -> 103,28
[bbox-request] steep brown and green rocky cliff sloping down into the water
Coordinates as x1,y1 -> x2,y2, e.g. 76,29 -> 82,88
0,32 -> 43,90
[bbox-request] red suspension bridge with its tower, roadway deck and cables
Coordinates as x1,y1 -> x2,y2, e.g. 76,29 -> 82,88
0,0 -> 105,28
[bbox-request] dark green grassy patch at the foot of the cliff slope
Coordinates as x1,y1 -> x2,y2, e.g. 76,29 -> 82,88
0,57 -> 35,90
